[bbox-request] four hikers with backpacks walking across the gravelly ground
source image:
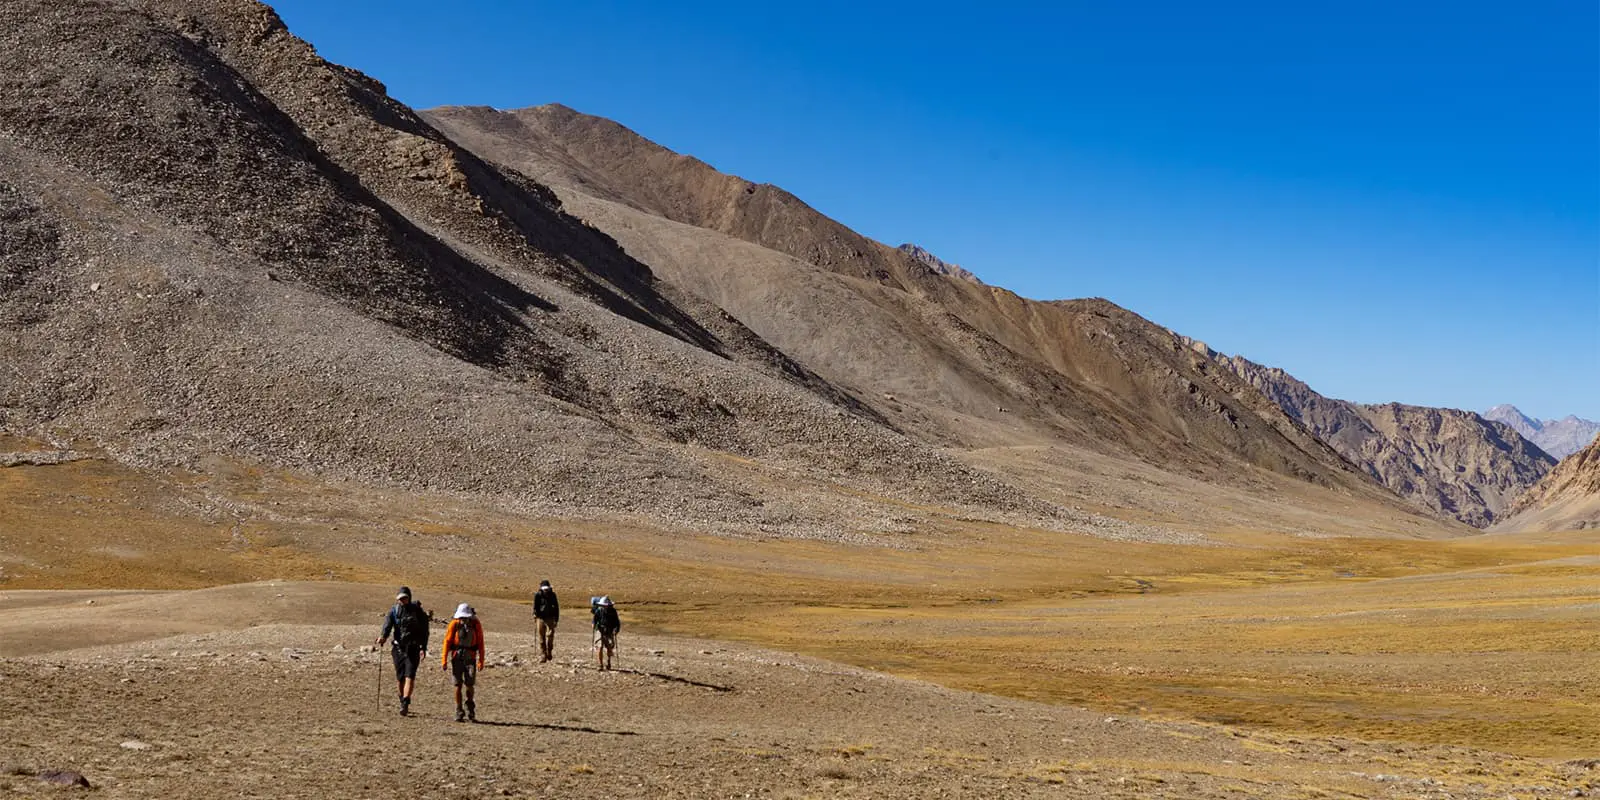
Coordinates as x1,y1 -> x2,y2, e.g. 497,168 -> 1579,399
378,581 -> 622,722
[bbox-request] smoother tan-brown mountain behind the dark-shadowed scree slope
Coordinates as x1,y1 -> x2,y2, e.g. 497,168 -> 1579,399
422,106 -> 1446,531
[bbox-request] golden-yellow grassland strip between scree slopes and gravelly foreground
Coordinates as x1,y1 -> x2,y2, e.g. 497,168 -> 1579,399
0,461 -> 1600,758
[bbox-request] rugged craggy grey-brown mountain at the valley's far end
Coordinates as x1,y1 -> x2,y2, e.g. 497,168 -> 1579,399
1216,354 -> 1555,528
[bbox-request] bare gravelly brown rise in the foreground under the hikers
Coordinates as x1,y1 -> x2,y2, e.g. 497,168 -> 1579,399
0,582 -> 1600,798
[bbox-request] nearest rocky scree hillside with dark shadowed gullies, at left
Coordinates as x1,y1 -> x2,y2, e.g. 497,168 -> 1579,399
0,0 -> 1058,533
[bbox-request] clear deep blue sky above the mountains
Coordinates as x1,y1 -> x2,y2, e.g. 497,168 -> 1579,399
272,0 -> 1600,419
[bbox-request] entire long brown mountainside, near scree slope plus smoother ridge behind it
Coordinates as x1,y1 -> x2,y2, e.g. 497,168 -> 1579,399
0,0 -> 1458,541
